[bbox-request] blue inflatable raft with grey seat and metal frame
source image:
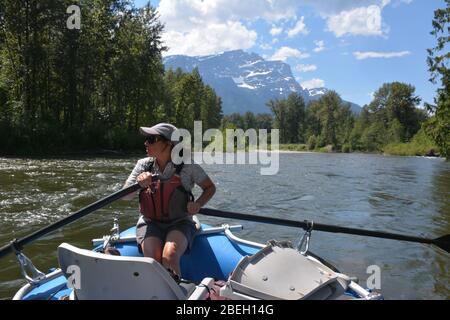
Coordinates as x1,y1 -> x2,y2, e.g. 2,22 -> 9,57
13,219 -> 382,300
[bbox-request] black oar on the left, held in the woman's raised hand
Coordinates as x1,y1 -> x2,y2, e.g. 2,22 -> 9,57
0,182 -> 142,258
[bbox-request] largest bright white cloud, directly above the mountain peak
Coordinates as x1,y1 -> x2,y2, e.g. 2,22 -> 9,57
157,0 -> 298,55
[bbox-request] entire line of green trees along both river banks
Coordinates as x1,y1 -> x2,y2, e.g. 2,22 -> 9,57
0,0 -> 450,157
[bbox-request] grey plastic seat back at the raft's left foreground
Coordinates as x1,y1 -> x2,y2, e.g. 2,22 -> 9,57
58,243 -> 205,300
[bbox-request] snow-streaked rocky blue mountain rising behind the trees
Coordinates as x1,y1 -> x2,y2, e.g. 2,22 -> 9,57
163,50 -> 361,114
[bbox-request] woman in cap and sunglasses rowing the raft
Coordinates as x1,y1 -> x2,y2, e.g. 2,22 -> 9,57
125,123 -> 216,277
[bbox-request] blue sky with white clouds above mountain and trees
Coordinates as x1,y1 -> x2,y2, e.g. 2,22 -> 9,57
135,0 -> 445,106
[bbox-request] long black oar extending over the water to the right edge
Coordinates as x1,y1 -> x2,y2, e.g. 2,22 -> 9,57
199,208 -> 450,252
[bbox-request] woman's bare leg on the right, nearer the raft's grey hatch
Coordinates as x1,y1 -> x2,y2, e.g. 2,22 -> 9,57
162,230 -> 188,277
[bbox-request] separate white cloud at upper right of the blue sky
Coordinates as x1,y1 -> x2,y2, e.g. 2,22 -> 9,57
327,5 -> 383,37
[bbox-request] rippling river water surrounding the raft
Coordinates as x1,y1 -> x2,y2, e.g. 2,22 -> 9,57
0,153 -> 450,299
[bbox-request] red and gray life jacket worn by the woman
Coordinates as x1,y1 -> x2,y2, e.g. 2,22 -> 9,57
139,162 -> 194,221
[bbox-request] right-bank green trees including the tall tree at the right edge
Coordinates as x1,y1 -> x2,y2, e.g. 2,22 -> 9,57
224,0 -> 450,160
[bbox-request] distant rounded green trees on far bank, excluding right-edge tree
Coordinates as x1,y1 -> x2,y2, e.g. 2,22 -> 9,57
224,82 -> 428,152
